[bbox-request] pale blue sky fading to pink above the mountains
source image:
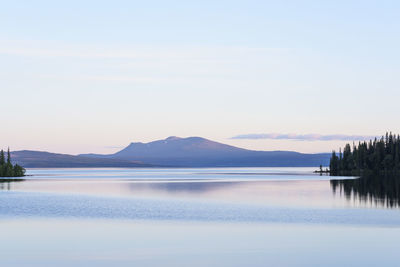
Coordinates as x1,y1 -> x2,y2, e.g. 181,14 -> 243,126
0,0 -> 400,154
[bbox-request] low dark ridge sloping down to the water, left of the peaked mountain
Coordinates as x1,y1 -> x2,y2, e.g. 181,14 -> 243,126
11,150 -> 151,168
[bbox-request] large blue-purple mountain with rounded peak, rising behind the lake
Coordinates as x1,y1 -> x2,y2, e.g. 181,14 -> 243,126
80,136 -> 330,167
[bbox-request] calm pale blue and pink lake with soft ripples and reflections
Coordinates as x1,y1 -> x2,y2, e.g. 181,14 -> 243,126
0,168 -> 400,266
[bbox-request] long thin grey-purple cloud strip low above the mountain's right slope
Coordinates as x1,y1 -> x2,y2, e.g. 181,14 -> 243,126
231,133 -> 375,141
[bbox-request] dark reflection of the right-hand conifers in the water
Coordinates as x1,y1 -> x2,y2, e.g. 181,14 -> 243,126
330,175 -> 400,208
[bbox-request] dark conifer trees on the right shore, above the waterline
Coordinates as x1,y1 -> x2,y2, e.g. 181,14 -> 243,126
329,133 -> 400,176
